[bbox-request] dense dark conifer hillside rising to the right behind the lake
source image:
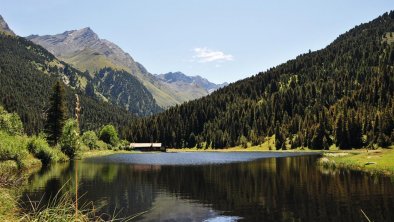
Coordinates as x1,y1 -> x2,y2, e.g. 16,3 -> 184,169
126,12 -> 394,149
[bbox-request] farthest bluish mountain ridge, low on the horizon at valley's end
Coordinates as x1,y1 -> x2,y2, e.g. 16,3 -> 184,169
156,72 -> 228,93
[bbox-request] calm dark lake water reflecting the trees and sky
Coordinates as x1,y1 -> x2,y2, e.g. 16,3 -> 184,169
22,152 -> 394,222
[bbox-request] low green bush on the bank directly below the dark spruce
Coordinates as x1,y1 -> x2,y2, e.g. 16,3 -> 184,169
27,137 -> 68,165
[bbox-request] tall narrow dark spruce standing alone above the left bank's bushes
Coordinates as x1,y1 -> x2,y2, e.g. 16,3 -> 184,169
45,81 -> 67,145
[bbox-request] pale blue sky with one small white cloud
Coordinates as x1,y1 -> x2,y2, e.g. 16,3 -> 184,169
0,0 -> 394,83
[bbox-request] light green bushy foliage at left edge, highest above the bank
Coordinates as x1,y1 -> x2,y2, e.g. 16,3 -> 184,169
0,106 -> 23,136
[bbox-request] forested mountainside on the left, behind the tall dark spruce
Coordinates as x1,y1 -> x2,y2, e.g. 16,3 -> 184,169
0,34 -> 133,134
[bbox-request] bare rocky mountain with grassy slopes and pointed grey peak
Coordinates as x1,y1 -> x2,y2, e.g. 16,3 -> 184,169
26,27 -> 223,108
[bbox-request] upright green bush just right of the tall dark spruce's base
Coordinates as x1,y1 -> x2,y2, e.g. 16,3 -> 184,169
60,119 -> 80,159
